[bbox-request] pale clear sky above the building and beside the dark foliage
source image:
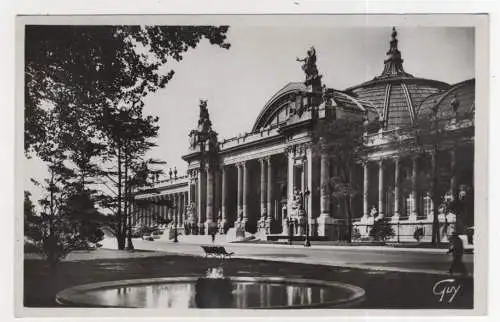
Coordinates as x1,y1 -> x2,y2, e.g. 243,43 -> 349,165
25,26 -> 475,204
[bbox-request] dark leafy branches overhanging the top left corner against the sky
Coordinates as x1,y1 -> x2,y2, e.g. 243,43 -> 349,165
25,25 -> 230,153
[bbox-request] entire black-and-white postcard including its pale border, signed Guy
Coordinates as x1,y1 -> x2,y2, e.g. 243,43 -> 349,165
16,14 -> 489,316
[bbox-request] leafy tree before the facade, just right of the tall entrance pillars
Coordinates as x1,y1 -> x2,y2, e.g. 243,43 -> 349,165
313,118 -> 364,242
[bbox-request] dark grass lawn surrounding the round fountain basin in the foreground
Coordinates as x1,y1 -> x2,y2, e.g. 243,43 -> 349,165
24,250 -> 473,309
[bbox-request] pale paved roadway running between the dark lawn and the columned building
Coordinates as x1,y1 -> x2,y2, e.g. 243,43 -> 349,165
99,236 -> 474,275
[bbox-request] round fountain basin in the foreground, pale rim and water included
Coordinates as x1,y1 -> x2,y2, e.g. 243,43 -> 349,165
56,277 -> 365,309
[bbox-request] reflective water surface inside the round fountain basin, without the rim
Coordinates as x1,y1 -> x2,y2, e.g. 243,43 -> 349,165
75,279 -> 350,309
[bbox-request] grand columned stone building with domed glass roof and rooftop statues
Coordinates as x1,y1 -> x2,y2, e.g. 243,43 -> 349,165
133,29 -> 475,241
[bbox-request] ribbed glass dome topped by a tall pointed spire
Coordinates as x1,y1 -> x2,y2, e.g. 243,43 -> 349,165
345,28 -> 450,129
